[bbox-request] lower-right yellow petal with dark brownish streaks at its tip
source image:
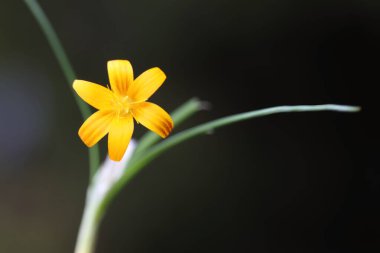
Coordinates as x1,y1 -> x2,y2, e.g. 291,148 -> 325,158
132,102 -> 173,138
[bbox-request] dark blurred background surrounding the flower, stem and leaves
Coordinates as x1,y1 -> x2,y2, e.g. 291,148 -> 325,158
0,0 -> 380,253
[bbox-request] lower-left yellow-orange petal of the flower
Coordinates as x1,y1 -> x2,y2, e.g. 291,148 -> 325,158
78,110 -> 116,147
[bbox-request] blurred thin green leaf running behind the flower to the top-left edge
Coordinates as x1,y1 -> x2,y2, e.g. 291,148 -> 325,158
24,0 -> 99,179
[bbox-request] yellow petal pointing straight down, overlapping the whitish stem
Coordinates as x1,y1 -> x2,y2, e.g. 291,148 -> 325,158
108,114 -> 133,161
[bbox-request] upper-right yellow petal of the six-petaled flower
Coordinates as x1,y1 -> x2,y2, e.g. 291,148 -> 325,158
127,68 -> 166,102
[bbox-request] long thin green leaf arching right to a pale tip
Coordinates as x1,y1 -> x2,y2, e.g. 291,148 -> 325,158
98,104 -> 360,214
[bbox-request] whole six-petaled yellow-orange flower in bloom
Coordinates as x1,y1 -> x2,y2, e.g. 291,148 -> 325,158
73,60 -> 173,161
